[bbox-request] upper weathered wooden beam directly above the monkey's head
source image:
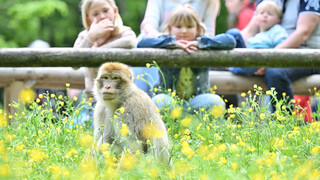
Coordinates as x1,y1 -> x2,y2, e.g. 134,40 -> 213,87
0,48 -> 320,67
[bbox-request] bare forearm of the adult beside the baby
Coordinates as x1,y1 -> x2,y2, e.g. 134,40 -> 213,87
275,13 -> 320,49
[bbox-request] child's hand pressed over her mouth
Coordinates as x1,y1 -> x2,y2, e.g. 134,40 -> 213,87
88,18 -> 114,42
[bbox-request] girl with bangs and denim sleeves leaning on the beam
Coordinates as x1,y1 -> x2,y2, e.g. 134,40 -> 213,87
138,4 -> 235,109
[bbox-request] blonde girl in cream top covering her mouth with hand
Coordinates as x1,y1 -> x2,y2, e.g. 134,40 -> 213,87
74,0 -> 136,97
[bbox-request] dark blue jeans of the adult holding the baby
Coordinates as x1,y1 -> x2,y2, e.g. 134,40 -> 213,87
265,68 -> 320,109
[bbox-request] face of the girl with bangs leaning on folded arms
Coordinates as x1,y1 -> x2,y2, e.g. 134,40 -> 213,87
170,23 -> 197,41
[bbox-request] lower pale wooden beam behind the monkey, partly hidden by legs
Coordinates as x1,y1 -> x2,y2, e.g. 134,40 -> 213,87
0,67 -> 320,95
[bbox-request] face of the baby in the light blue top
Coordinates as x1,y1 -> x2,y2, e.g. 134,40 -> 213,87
257,9 -> 280,32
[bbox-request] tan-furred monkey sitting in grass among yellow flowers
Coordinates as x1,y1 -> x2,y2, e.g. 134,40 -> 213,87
93,62 -> 170,163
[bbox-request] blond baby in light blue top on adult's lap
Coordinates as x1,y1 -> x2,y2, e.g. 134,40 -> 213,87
227,1 -> 288,75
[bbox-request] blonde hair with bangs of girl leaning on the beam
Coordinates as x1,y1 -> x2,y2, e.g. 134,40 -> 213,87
162,4 -> 206,36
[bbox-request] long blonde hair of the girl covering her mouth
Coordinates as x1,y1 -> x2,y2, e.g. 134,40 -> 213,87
81,0 -> 123,35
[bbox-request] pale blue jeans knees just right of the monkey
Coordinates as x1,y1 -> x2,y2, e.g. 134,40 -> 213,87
152,93 -> 226,111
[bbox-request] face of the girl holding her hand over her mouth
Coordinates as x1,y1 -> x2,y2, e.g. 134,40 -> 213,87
87,0 -> 118,24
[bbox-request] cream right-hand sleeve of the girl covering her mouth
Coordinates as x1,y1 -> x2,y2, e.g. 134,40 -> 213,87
100,26 -> 137,48
